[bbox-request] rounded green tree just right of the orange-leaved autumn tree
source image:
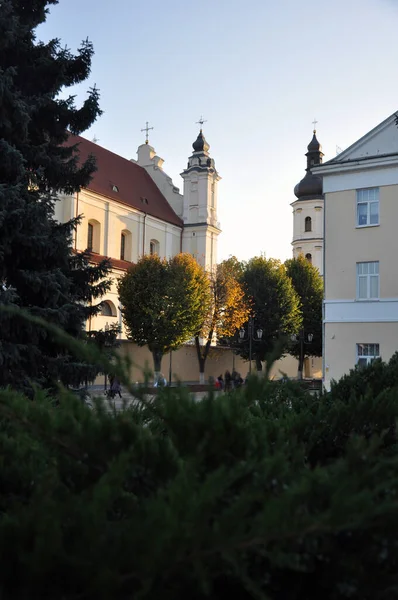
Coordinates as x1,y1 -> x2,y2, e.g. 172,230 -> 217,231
236,256 -> 302,371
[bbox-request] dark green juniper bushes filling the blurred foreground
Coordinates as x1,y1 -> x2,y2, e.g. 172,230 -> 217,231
0,330 -> 398,600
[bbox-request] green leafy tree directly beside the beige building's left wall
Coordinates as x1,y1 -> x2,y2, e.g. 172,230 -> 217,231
285,255 -> 323,378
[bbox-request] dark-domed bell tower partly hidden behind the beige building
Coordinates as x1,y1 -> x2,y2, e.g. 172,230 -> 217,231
291,129 -> 324,275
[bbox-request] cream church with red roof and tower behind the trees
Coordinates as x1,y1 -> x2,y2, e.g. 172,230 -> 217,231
55,127 -> 221,338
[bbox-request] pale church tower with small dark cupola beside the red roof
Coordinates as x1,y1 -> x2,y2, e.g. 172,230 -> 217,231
181,122 -> 221,270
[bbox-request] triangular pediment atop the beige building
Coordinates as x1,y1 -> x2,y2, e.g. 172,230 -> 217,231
325,114 -> 398,164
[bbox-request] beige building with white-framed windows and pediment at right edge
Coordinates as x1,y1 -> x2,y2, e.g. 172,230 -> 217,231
314,115 -> 398,389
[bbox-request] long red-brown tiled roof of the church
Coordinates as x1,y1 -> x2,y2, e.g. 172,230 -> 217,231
67,135 -> 183,227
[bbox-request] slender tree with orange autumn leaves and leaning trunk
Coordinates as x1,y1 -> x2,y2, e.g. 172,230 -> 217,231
195,257 -> 249,383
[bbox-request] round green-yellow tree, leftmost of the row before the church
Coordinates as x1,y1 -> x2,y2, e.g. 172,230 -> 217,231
118,254 -> 209,376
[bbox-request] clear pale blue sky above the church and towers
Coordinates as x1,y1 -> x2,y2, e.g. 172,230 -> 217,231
38,0 -> 398,260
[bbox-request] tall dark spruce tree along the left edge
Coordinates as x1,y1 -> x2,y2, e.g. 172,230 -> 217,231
0,0 -> 109,389
